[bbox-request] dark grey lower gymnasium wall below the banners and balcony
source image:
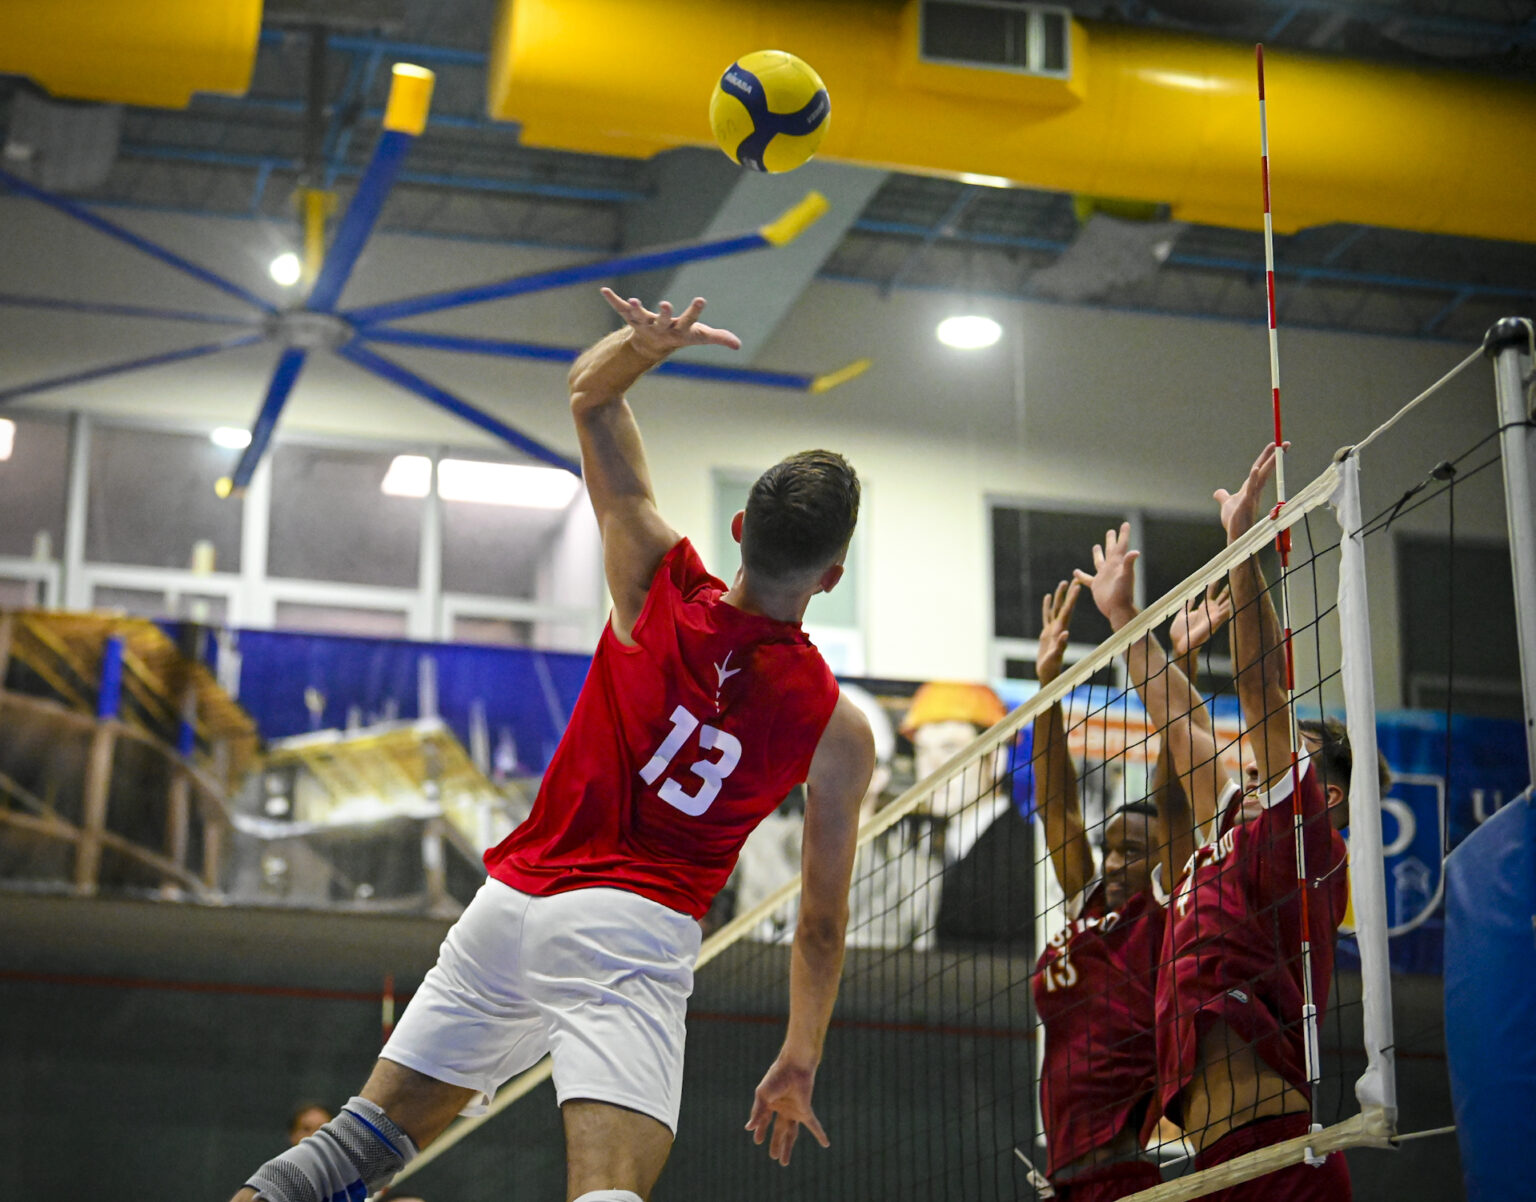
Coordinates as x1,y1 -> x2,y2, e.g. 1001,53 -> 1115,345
0,893 -> 1461,1202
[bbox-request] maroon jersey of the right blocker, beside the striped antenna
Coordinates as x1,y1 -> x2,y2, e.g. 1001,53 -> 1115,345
1143,763 -> 1349,1130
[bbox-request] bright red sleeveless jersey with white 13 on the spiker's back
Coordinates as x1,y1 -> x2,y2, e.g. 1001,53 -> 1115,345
485,539 -> 837,918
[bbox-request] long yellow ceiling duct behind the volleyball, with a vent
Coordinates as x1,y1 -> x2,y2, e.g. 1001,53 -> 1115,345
488,0 -> 1536,241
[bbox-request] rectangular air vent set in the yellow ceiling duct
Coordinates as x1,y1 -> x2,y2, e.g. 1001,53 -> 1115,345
920,0 -> 1072,78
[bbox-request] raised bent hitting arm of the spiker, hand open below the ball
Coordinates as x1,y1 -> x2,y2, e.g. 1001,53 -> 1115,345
570,289 -> 742,643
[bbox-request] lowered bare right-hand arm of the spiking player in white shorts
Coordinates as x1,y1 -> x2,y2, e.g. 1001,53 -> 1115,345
746,697 -> 874,1165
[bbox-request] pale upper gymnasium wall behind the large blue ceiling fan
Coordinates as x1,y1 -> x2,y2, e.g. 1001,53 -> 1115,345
0,198 -> 1504,705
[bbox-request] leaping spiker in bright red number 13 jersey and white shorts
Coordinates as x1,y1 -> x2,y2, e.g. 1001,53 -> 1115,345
227,289 -> 874,1202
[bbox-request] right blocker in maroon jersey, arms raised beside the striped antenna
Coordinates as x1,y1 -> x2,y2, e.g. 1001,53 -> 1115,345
1087,445 -> 1350,1202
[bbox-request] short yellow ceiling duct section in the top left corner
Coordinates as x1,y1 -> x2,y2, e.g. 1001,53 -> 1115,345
0,0 -> 261,109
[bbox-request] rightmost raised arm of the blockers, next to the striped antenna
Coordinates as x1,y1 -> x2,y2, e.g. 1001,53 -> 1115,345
1215,444 -> 1290,789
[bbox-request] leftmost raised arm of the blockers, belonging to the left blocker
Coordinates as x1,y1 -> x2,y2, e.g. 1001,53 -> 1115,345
1034,580 -> 1094,898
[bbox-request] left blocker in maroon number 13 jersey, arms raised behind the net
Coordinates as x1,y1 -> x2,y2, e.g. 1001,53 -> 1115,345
1034,582 -> 1226,1202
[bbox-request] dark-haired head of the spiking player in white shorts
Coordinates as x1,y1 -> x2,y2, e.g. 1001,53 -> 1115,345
742,451 -> 859,580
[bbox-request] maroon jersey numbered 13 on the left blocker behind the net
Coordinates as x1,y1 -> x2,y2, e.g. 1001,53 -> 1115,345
1034,880 -> 1163,1176
